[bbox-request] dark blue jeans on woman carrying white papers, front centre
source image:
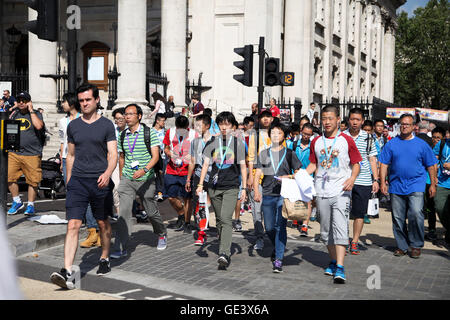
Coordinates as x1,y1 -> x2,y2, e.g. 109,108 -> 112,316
261,196 -> 287,260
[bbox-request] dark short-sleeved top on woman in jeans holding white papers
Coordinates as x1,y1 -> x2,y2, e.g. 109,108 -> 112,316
256,148 -> 302,196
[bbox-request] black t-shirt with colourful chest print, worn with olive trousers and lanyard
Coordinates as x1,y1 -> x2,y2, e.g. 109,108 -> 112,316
203,136 -> 245,190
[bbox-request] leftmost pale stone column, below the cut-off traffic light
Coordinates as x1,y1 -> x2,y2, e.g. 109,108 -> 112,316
28,9 -> 57,112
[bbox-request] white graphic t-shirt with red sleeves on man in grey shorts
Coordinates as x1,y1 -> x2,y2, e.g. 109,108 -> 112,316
309,133 -> 362,198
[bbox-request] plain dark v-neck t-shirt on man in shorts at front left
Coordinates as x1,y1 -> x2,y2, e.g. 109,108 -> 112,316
67,117 -> 116,178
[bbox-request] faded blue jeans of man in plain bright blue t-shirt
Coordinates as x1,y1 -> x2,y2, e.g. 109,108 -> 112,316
391,192 -> 425,251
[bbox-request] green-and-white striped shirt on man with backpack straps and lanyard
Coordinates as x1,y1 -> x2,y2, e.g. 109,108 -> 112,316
118,125 -> 159,181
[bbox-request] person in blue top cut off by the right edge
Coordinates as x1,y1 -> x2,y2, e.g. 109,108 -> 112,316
433,138 -> 450,244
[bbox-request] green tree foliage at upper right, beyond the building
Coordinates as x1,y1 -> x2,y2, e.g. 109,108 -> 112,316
394,0 -> 450,110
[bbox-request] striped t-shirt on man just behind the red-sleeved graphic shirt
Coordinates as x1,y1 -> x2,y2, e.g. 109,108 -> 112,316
344,130 -> 378,186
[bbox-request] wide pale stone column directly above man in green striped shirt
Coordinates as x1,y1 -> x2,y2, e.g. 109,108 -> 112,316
116,0 -> 147,111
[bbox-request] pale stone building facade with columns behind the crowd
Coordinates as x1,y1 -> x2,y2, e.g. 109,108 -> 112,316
0,0 -> 406,157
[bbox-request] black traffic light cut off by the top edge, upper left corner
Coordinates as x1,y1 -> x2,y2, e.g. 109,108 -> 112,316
24,0 -> 59,41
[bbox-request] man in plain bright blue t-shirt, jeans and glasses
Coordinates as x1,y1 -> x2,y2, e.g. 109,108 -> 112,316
379,114 -> 437,258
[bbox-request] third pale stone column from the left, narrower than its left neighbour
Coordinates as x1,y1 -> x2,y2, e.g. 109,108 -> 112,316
161,0 -> 186,105
